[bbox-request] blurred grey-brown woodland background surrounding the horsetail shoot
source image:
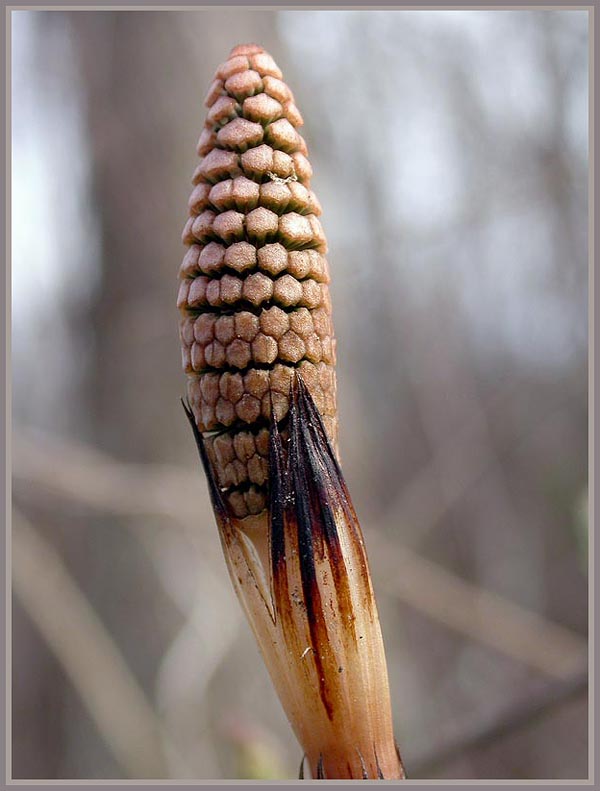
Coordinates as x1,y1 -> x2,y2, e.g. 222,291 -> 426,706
11,9 -> 588,779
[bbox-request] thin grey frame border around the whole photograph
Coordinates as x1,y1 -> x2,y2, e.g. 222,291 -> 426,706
0,0 -> 600,791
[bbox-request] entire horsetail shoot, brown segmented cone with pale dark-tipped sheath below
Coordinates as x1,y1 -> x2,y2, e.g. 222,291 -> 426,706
178,45 -> 404,780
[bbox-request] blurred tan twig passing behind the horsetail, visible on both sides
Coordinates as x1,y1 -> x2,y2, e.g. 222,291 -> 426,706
13,431 -> 587,678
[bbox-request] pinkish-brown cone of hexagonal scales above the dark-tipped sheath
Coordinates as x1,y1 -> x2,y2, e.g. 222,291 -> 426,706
178,45 -> 337,518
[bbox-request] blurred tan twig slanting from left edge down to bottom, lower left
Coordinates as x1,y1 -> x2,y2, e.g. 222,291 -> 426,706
12,511 -> 185,779
